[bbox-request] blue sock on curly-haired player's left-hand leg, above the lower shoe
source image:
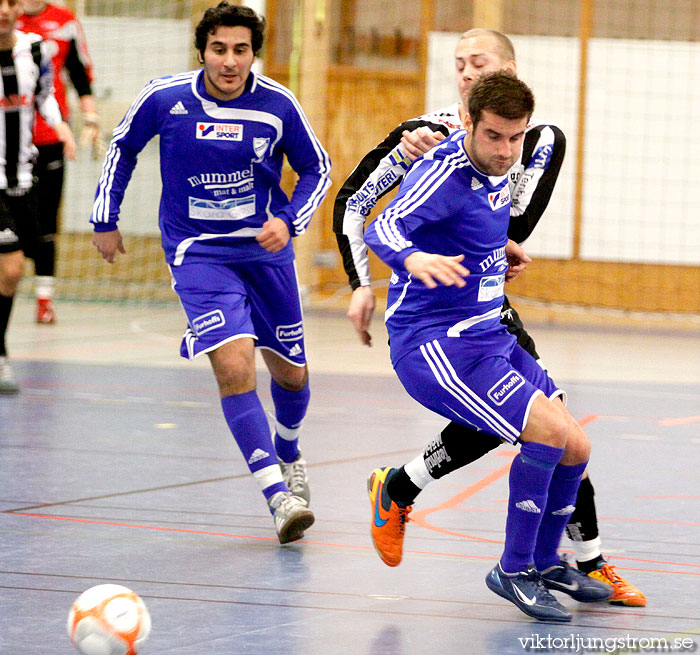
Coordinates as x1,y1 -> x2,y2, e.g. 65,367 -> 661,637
221,391 -> 289,500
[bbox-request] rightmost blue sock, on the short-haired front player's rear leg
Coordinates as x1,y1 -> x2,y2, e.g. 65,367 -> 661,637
535,462 -> 588,571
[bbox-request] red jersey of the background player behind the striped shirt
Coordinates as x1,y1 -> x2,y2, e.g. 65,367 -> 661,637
17,4 -> 92,146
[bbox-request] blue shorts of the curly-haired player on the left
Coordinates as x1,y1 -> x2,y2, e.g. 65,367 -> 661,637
170,261 -> 306,366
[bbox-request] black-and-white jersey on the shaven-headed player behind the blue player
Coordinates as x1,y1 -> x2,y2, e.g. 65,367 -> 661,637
333,103 -> 566,290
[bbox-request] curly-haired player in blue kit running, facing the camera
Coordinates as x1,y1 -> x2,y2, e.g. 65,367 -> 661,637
91,2 -> 330,543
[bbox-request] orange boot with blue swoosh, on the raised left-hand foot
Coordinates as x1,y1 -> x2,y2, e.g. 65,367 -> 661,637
367,467 -> 412,566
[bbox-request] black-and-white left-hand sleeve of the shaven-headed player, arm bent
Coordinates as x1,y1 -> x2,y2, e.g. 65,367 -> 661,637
333,119 -> 449,290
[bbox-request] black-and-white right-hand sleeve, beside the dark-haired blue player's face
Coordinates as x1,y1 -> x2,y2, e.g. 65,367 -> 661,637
508,125 -> 566,243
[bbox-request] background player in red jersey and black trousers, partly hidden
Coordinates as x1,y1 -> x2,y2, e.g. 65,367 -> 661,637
17,0 -> 104,324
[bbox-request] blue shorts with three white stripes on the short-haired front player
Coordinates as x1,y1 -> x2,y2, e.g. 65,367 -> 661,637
395,328 -> 566,443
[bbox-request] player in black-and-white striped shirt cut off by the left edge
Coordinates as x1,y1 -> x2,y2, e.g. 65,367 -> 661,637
0,0 -> 75,393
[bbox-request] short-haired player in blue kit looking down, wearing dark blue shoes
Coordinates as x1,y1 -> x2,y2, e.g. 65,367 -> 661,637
365,72 -> 612,622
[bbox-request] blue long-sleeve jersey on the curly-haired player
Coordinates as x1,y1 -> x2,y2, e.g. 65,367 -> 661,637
90,69 -> 330,266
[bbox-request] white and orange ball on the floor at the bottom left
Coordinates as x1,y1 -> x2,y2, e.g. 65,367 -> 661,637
68,584 -> 151,655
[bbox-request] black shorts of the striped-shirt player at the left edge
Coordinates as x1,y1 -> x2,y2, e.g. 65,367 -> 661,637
0,189 -> 40,258
